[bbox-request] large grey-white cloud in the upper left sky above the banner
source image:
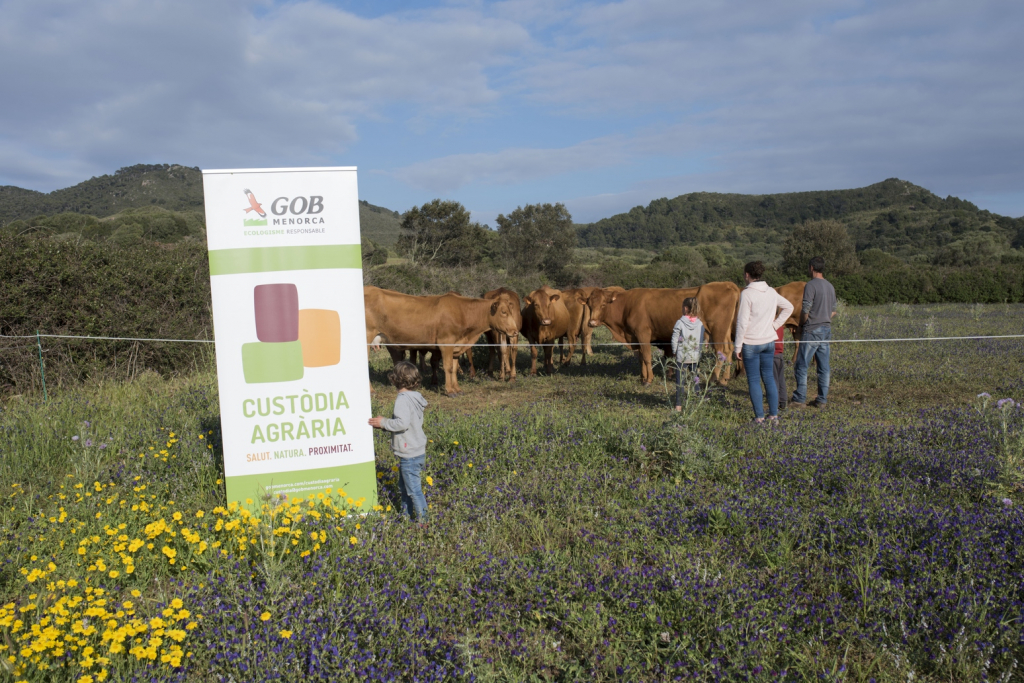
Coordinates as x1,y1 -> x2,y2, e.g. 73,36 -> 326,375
0,0 -> 528,186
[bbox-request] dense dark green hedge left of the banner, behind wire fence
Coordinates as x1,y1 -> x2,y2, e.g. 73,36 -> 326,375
0,229 -> 213,393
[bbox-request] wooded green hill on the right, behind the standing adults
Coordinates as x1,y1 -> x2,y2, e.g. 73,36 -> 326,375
578,178 -> 1024,260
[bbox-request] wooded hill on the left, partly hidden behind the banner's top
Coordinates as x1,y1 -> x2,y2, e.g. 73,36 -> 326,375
0,164 -> 401,247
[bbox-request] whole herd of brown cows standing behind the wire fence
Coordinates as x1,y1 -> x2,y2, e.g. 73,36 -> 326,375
362,282 -> 804,396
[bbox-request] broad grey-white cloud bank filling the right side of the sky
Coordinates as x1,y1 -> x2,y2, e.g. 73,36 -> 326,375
395,0 -> 1024,208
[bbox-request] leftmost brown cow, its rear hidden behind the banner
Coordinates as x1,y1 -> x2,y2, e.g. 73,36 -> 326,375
362,287 -> 518,396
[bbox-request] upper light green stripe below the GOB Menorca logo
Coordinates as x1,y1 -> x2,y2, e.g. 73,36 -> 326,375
210,245 -> 362,275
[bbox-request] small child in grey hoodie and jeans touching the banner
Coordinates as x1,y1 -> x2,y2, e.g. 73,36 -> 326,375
370,360 -> 427,523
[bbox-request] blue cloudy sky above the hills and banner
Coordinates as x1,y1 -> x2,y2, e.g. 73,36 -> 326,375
0,0 -> 1024,225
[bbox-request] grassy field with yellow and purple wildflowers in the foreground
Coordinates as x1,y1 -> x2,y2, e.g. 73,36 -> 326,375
0,305 -> 1024,683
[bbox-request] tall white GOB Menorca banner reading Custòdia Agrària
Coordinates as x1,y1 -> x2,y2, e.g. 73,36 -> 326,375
203,163 -> 377,508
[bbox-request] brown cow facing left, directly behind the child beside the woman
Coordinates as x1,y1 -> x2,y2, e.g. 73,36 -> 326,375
587,283 -> 739,385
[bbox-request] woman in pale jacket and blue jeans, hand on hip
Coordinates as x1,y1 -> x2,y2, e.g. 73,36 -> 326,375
736,261 -> 793,422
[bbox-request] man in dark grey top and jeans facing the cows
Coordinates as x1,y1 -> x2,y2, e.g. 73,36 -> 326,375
790,256 -> 836,408
